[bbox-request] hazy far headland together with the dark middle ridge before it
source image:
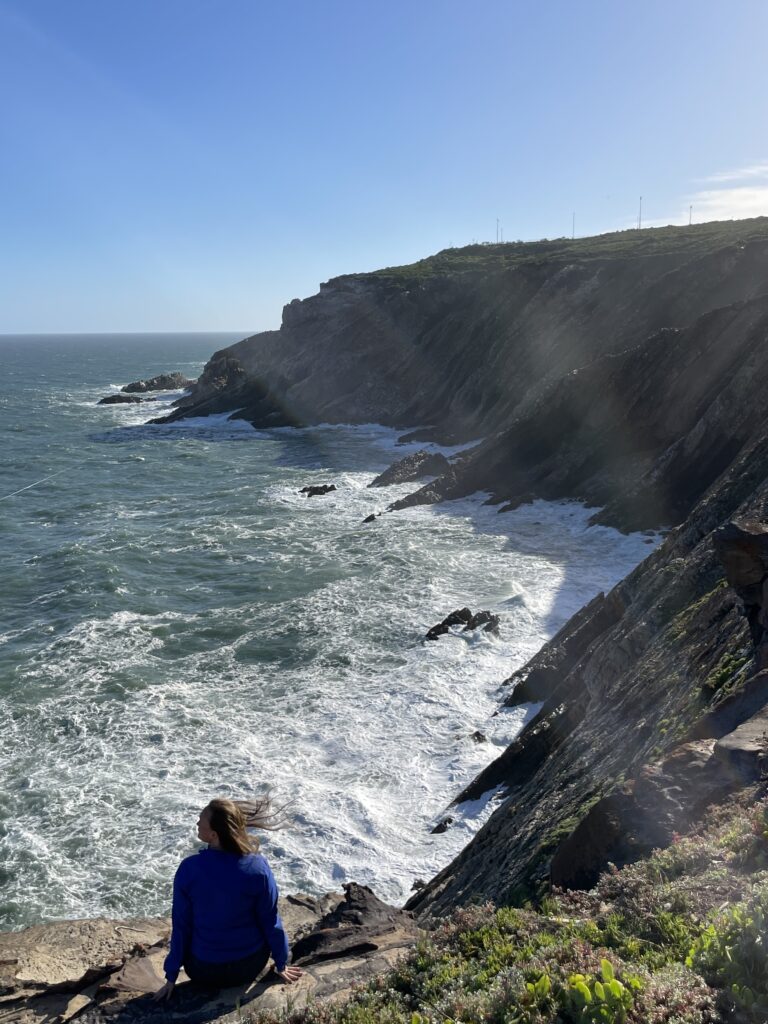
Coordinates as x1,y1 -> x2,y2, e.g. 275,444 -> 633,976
153,218 -> 768,528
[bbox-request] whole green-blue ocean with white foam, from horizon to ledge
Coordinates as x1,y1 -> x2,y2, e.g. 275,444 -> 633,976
0,334 -> 655,929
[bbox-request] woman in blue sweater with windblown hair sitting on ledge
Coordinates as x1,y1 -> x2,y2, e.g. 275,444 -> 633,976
155,799 -> 302,999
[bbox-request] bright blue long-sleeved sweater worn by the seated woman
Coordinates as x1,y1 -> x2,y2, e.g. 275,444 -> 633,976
165,849 -> 288,982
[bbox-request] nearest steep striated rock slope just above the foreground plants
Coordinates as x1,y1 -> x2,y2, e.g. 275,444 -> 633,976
408,429 -> 768,914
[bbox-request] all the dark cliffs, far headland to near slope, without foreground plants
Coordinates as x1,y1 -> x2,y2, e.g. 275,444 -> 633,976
163,218 -> 768,914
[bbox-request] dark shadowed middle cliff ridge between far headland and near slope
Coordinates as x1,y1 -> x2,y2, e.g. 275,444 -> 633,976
394,294 -> 768,529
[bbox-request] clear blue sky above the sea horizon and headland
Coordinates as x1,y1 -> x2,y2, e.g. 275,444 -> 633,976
0,0 -> 768,333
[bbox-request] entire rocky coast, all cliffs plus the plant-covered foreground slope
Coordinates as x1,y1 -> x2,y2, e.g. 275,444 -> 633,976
9,218 -> 768,1024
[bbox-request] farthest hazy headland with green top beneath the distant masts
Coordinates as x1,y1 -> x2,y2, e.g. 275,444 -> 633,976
156,218 -> 768,458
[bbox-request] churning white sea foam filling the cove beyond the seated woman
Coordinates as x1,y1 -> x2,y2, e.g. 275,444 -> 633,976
0,430 -> 663,923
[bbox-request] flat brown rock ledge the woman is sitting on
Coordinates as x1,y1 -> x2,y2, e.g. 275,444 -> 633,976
0,884 -> 419,1024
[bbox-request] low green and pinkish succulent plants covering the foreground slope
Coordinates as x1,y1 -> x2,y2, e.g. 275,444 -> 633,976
250,794 -> 768,1024
